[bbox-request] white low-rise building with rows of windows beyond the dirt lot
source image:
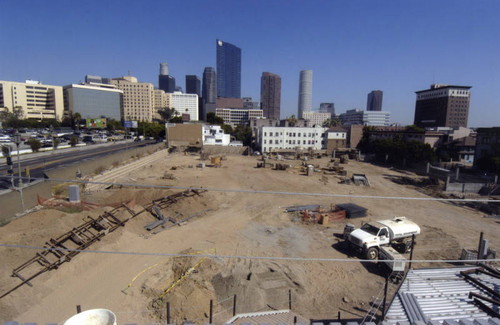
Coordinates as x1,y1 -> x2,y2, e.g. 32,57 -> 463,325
257,126 -> 328,152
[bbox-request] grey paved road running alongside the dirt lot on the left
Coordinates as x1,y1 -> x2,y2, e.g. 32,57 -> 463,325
0,140 -> 155,190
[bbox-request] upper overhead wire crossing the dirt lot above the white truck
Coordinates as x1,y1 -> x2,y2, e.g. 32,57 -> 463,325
0,176 -> 500,203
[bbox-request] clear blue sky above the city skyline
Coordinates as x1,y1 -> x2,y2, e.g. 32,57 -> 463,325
0,0 -> 500,127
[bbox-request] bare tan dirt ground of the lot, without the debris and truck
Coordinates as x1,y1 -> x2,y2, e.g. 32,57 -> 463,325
0,151 -> 500,324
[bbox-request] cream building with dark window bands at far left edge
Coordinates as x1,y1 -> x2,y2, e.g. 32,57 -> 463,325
0,80 -> 64,121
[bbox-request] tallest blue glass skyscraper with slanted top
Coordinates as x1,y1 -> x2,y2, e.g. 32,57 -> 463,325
216,40 -> 241,98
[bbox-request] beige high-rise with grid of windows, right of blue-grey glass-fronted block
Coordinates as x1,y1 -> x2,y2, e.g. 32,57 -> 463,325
111,76 -> 155,122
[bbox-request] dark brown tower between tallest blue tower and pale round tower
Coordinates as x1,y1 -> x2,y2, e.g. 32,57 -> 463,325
260,72 -> 281,120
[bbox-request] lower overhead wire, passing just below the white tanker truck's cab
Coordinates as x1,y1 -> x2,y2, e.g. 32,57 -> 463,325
0,244 -> 500,263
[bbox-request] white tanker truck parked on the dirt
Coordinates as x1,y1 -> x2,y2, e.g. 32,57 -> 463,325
344,217 -> 420,260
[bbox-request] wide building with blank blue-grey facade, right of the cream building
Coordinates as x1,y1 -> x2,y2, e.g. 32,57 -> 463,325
63,82 -> 123,121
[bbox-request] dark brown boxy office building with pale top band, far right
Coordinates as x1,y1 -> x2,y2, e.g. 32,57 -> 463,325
413,84 -> 472,128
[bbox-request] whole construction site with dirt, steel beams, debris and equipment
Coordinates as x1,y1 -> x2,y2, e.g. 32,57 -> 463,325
0,149 -> 500,324
